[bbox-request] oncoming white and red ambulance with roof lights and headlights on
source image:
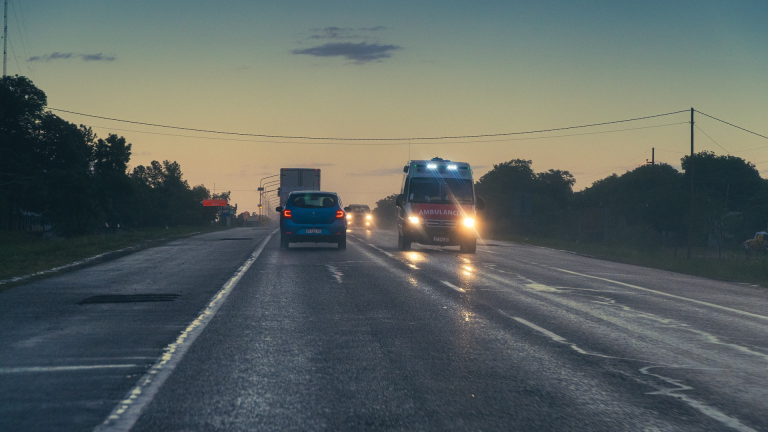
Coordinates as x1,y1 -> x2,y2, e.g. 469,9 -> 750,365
395,158 -> 485,253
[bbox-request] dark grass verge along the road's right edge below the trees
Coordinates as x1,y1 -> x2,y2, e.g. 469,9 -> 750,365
487,235 -> 768,287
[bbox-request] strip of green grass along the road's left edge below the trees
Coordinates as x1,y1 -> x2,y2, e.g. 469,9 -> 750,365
0,226 -> 226,284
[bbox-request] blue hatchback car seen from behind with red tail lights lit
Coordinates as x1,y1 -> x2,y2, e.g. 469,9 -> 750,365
275,191 -> 347,249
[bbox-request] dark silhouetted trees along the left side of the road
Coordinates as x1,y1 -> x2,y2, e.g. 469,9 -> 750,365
0,75 -> 228,235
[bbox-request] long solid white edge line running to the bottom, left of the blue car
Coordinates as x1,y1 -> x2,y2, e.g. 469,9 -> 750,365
94,230 -> 278,432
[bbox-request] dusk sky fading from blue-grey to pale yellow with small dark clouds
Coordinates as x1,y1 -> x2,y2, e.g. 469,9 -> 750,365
3,0 -> 768,211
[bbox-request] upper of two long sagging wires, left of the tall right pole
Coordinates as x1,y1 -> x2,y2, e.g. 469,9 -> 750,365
49,107 -> 688,141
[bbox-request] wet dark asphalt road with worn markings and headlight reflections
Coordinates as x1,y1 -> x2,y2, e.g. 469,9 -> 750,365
0,229 -> 768,431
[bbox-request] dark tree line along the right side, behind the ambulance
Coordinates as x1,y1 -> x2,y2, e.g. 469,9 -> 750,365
374,151 -> 768,249
